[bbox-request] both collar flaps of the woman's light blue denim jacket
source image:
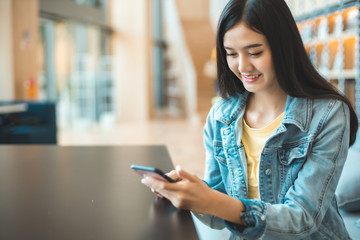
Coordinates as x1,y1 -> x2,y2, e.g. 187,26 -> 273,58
214,91 -> 313,132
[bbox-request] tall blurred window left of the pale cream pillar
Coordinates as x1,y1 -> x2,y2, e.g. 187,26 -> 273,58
39,0 -> 115,128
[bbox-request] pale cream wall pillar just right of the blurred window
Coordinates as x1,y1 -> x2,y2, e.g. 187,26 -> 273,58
109,0 -> 152,121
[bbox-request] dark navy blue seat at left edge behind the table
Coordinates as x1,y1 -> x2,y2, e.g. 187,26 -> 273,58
0,101 -> 57,144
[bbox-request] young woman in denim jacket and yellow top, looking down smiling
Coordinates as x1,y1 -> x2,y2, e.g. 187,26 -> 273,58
142,0 -> 358,240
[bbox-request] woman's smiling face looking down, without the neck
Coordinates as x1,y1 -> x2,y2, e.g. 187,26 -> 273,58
224,22 -> 280,93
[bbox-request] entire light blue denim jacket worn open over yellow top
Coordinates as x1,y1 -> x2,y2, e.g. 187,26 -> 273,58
197,93 -> 350,240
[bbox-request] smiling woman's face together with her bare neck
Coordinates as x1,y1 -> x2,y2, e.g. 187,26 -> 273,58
224,22 -> 286,128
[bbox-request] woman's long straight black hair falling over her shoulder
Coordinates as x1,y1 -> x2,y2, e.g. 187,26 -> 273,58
216,0 -> 358,145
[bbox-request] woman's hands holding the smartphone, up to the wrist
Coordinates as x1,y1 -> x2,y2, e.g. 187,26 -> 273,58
141,167 -> 214,213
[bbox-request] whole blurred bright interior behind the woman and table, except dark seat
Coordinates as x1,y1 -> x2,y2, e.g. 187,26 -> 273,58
0,0 -> 360,175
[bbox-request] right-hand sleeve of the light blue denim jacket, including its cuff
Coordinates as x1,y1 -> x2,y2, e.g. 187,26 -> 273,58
226,101 -> 350,239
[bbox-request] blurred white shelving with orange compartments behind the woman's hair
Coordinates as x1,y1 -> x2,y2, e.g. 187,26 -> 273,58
286,0 -> 360,117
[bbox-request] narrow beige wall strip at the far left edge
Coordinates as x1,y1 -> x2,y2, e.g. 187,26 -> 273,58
0,0 -> 14,101
